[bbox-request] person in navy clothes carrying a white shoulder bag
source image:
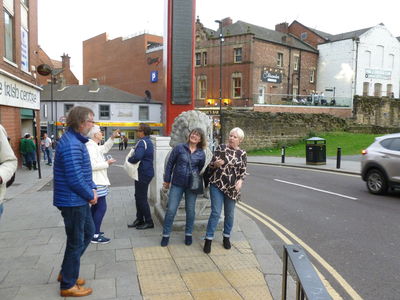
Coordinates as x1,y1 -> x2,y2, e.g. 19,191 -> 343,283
128,123 -> 154,229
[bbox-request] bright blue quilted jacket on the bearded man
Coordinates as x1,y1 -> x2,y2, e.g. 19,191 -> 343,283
53,128 -> 96,207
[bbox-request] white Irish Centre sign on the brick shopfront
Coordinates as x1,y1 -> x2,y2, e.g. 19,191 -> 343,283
0,73 -> 40,110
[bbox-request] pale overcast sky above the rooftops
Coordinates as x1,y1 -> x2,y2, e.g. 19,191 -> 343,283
38,0 -> 400,84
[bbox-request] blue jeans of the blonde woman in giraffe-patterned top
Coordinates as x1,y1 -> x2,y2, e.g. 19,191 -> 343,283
206,184 -> 236,240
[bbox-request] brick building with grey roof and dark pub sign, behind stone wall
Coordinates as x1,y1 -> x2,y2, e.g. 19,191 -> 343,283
195,18 -> 318,111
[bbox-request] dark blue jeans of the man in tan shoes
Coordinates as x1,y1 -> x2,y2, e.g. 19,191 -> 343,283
58,204 -> 94,290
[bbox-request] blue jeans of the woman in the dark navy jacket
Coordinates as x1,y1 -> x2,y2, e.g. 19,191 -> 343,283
163,184 -> 197,237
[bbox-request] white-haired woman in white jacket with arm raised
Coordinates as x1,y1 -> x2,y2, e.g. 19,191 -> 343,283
86,125 -> 119,244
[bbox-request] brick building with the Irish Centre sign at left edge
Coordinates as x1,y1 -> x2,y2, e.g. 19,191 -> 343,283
0,0 -> 41,162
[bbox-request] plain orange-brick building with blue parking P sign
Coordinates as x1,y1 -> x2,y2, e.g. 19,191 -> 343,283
83,33 -> 165,101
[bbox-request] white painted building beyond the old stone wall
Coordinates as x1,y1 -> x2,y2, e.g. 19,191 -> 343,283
317,24 -> 400,105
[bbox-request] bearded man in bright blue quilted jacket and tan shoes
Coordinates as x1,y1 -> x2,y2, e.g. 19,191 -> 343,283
53,106 -> 97,297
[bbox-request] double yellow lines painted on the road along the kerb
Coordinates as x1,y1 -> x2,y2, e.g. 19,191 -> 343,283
237,202 -> 362,299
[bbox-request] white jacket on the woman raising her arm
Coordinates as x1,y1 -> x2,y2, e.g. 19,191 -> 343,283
86,138 -> 114,185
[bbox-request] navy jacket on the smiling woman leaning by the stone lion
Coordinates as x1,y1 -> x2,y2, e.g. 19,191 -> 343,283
164,144 -> 206,188
